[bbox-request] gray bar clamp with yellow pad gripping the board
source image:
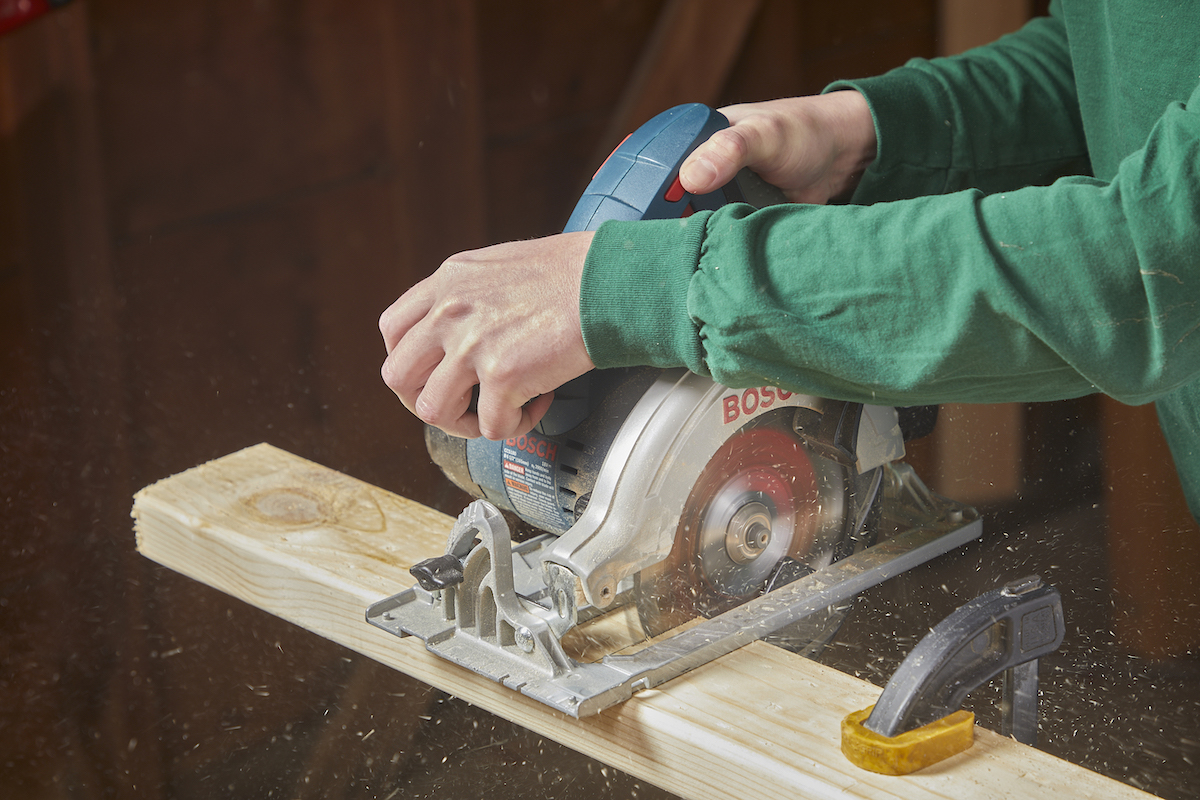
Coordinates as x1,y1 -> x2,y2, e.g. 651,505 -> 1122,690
841,576 -> 1064,775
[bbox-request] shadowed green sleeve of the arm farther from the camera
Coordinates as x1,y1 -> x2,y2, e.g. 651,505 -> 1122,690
826,10 -> 1091,204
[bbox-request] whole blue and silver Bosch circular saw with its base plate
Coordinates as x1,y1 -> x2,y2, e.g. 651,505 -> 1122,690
367,104 -> 980,716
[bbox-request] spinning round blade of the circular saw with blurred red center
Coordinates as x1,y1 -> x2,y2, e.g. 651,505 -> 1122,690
636,413 -> 854,637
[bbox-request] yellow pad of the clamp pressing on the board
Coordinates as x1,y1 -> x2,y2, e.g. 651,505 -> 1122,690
841,705 -> 974,775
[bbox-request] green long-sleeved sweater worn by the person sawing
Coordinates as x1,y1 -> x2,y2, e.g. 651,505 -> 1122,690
581,0 -> 1200,513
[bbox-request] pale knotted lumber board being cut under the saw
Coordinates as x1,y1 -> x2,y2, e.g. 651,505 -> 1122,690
133,445 -> 1150,800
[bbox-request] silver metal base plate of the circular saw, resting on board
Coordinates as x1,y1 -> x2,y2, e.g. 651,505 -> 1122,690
366,464 -> 982,717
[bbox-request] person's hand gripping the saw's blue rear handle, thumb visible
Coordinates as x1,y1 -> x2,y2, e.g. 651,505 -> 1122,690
679,91 -> 876,204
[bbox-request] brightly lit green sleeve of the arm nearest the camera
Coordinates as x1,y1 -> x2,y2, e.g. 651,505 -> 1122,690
581,82 -> 1200,404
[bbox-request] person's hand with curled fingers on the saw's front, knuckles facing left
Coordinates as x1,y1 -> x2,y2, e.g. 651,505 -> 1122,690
379,231 -> 593,439
